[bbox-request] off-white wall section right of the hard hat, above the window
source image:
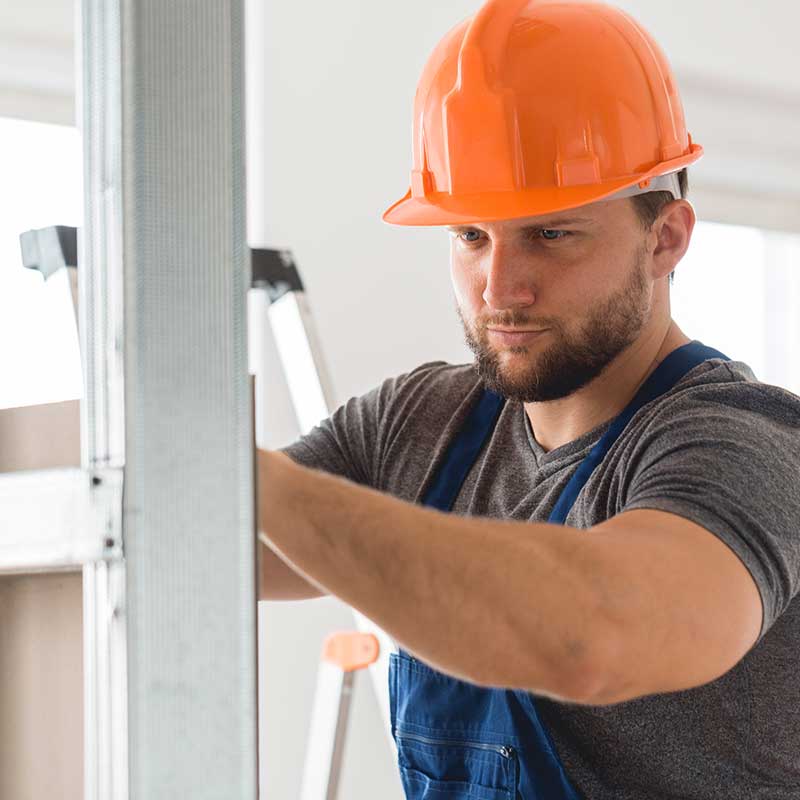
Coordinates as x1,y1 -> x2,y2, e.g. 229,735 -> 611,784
618,0 -> 800,232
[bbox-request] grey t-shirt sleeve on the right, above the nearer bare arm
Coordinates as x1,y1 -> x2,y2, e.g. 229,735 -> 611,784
622,383 -> 800,641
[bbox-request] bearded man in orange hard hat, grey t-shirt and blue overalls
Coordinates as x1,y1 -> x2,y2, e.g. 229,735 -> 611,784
258,0 -> 800,800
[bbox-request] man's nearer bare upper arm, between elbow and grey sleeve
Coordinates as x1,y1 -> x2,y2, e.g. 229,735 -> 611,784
589,509 -> 763,705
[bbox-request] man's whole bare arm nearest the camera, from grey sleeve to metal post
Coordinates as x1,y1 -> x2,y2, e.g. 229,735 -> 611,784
258,451 -> 761,705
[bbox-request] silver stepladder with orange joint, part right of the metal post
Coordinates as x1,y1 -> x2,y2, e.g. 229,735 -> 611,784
251,249 -> 395,800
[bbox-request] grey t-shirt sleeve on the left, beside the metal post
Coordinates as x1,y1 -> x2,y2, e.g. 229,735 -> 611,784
280,362 -> 450,489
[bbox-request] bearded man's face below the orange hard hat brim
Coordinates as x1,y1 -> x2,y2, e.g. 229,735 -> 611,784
448,199 -> 653,403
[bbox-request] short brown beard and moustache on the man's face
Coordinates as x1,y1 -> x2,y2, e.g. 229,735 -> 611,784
457,251 -> 651,403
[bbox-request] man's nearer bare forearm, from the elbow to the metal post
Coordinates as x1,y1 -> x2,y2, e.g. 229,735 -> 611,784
258,451 -> 602,702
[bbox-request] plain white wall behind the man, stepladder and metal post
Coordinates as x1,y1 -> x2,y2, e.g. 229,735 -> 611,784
0,0 -> 800,800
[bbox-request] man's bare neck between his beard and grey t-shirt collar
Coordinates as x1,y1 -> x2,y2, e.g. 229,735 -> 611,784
525,320 -> 691,452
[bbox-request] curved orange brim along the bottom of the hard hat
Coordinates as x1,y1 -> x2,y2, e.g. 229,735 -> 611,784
383,144 -> 703,226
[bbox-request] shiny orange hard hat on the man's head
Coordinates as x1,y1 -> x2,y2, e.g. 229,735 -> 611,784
383,0 -> 703,225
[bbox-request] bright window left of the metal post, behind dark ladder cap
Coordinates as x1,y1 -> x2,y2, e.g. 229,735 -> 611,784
0,118 -> 83,408
